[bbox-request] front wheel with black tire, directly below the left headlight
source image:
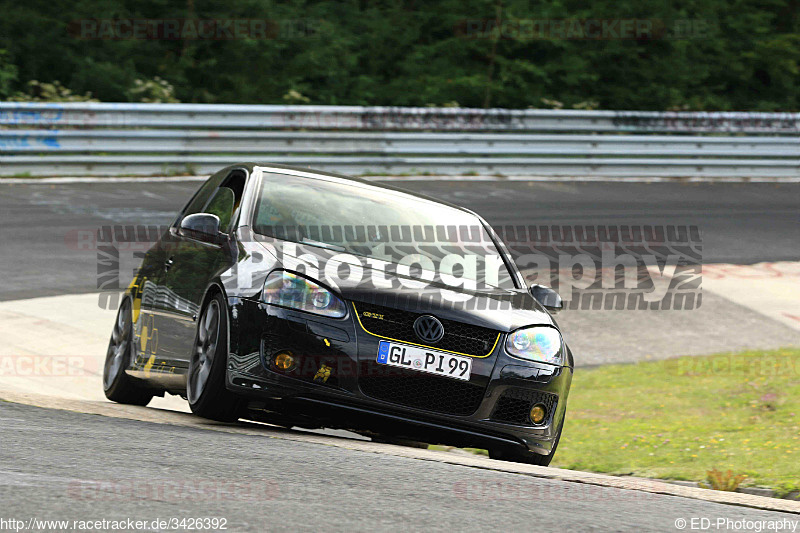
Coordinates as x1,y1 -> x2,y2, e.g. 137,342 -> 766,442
186,293 -> 242,422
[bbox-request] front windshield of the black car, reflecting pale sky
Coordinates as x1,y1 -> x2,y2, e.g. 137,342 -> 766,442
252,172 -> 514,289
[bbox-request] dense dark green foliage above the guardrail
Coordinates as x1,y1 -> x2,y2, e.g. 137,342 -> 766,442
0,0 -> 800,110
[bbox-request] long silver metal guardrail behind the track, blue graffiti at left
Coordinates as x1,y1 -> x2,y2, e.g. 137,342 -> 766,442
0,102 -> 800,177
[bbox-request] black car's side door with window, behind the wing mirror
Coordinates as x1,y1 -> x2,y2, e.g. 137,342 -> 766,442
159,169 -> 246,369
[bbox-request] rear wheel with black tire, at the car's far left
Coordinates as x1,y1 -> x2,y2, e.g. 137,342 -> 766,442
103,298 -> 153,405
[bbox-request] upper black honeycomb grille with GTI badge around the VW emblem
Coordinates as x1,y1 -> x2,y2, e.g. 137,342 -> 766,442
356,303 -> 500,357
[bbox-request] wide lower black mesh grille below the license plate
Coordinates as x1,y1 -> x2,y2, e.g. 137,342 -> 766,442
358,361 -> 486,416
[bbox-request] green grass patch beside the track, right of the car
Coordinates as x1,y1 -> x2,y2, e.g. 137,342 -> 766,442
553,349 -> 800,493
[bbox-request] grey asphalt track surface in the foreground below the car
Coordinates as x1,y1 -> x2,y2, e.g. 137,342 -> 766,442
0,402 -> 800,532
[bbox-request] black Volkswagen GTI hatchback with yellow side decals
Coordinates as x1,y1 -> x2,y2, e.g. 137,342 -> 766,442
103,164 -> 574,465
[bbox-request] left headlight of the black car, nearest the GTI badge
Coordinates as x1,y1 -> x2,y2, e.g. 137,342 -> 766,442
263,270 -> 347,318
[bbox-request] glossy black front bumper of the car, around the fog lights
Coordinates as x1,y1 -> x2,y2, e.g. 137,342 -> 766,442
227,298 -> 572,454
